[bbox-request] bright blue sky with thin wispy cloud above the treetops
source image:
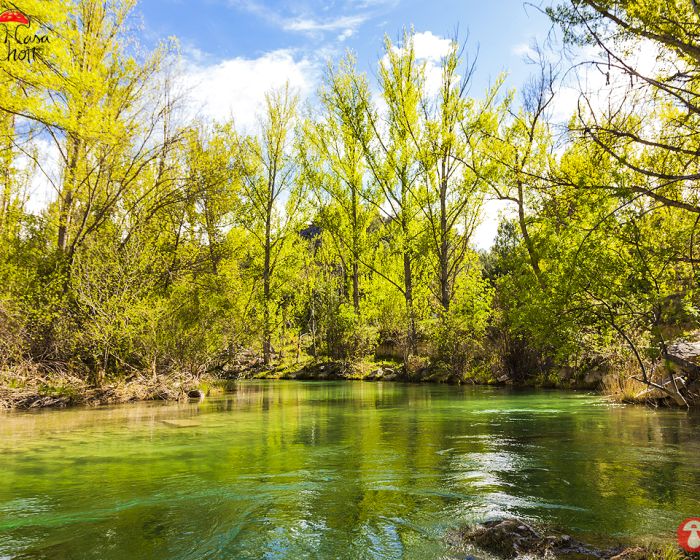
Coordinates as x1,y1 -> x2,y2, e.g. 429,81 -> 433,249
138,0 -> 549,99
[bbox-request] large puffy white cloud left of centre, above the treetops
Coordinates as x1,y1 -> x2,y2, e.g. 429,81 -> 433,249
183,49 -> 320,132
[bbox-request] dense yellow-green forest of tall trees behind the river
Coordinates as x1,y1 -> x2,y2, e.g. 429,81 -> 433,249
0,0 -> 700,405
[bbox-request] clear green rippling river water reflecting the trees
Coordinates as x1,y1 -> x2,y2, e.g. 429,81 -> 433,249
0,381 -> 700,560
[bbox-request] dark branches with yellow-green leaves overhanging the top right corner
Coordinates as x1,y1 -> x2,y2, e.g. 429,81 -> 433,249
547,0 -> 700,215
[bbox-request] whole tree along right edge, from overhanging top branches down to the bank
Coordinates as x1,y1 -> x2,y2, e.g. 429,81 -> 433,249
547,0 -> 700,400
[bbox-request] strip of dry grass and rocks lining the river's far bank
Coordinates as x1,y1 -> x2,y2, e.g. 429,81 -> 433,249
0,359 -> 696,410
